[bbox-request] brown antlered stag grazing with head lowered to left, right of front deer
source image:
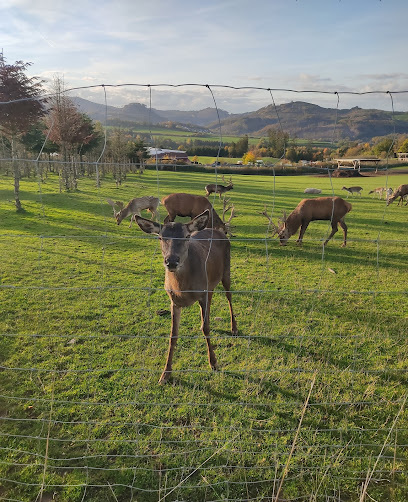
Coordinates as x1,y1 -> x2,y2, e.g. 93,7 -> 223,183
261,197 -> 352,247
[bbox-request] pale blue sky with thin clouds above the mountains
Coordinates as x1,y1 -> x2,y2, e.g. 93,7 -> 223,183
0,0 -> 408,113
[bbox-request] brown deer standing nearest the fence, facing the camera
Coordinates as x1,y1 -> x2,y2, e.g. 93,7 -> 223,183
135,209 -> 238,384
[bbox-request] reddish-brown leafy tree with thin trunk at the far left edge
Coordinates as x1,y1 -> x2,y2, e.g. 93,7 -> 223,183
0,54 -> 45,211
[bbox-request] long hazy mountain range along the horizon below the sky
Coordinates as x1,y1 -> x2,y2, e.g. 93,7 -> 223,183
72,98 -> 408,141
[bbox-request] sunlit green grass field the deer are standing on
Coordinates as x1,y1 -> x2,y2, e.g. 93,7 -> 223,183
0,171 -> 408,502
